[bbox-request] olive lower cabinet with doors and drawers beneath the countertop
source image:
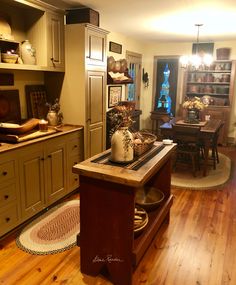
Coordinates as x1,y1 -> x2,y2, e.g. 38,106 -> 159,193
0,126 -> 83,236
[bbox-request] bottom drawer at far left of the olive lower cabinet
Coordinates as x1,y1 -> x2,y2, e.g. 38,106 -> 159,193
0,204 -> 18,236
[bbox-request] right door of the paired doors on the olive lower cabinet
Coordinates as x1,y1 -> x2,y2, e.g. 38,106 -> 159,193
45,137 -> 66,204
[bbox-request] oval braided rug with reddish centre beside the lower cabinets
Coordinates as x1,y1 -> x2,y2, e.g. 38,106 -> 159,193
16,200 -> 80,255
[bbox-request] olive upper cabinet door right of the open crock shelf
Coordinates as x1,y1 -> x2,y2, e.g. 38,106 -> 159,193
47,12 -> 65,69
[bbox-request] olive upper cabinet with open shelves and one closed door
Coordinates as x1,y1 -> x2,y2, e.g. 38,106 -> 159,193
0,0 -> 64,71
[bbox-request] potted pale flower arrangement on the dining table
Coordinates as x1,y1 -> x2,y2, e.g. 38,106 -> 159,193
183,97 -> 207,124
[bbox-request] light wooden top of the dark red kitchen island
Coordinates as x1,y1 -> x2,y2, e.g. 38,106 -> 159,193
73,142 -> 176,187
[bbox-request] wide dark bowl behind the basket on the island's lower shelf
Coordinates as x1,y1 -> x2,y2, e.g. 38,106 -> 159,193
135,186 -> 165,211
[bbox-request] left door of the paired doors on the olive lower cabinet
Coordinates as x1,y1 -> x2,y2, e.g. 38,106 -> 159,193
19,144 -> 45,219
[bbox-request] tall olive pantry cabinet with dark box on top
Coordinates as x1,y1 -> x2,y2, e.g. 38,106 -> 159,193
60,24 -> 108,158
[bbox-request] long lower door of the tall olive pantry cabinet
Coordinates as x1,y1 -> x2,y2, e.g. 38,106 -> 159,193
86,71 -> 105,157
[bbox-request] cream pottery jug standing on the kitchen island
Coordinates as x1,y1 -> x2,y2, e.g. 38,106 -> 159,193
111,127 -> 134,162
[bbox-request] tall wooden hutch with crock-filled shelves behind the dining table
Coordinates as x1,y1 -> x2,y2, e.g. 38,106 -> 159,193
184,60 -> 235,144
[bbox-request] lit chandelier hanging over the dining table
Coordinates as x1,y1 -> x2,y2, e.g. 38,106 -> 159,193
180,24 -> 213,69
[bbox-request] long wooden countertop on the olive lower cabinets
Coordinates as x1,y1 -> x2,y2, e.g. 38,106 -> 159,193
0,124 -> 83,153
